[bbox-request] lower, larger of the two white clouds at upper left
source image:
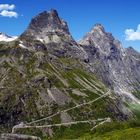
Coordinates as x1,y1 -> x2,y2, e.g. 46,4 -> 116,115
0,10 -> 18,18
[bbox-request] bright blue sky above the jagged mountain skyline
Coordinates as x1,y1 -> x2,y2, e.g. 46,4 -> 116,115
0,0 -> 140,51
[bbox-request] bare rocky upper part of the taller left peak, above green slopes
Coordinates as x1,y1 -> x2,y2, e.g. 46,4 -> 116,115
20,9 -> 87,60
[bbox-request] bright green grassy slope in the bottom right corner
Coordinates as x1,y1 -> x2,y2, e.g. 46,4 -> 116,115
77,121 -> 140,140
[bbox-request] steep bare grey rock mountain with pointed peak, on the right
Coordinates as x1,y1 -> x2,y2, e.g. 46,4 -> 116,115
79,24 -> 140,103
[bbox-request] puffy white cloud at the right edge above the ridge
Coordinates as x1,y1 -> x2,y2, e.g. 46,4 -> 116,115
125,24 -> 140,41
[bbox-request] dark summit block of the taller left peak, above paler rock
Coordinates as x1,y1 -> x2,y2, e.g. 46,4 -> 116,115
21,9 -> 72,39
